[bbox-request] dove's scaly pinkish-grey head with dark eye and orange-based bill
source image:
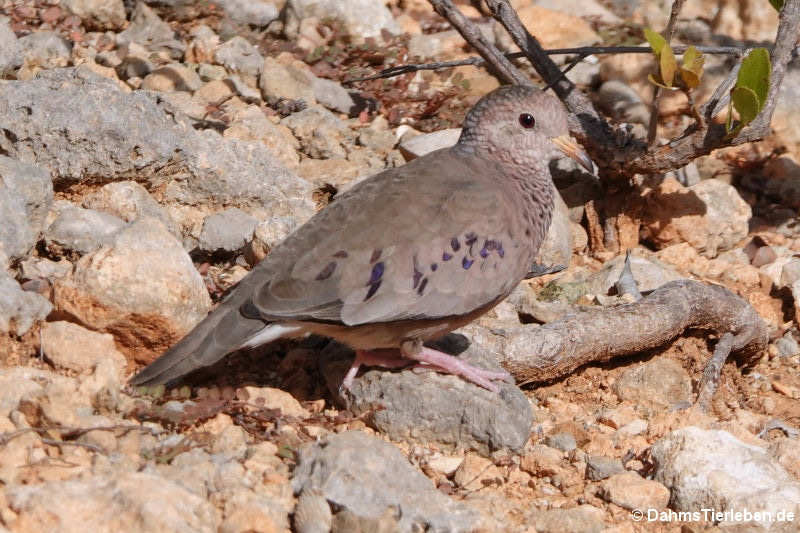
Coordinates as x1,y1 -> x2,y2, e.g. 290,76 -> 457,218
458,85 -> 592,172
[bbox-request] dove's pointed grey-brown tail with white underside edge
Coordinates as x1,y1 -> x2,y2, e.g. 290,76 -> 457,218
130,280 -> 290,385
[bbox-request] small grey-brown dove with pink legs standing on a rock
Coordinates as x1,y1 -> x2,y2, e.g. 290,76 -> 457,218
130,85 -> 592,391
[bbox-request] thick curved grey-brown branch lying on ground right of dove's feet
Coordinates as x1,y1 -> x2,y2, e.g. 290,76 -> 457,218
502,280 -> 768,386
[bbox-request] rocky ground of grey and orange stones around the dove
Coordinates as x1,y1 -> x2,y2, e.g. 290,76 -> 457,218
0,0 -> 800,533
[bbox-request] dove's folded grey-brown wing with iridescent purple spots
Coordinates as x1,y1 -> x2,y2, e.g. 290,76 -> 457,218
247,150 -> 538,325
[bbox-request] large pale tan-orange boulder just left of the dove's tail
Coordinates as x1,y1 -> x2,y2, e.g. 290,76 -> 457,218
54,217 -> 211,360
